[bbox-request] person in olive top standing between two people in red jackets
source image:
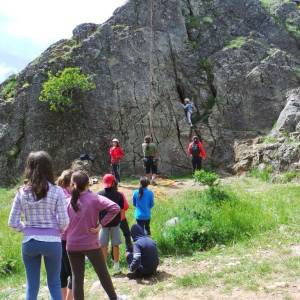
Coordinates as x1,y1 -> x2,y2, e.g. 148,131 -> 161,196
142,135 -> 158,185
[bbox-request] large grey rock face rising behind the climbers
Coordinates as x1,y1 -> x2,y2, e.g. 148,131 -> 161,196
0,0 -> 300,183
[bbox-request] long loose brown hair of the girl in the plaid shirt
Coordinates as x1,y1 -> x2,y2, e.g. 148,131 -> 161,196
24,151 -> 55,200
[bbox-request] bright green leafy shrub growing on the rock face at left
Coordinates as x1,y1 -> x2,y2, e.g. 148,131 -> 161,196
39,67 -> 95,112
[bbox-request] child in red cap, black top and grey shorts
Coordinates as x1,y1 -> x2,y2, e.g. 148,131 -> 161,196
99,174 -> 124,273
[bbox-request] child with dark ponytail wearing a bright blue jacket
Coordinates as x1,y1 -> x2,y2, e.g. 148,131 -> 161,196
133,177 -> 154,235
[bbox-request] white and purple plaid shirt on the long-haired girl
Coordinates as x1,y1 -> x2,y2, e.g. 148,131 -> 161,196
8,183 -> 69,236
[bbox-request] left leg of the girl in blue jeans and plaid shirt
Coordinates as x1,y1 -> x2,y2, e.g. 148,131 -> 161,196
22,240 -> 42,300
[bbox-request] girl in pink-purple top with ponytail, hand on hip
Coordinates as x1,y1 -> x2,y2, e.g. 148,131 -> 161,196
67,171 -> 124,300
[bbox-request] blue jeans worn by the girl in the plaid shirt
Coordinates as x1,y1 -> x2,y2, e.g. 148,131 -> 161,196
22,239 -> 62,300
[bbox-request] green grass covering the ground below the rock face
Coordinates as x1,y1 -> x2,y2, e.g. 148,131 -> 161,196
0,175 -> 300,299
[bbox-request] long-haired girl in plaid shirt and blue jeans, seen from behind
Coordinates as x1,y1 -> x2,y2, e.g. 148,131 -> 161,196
8,151 -> 69,300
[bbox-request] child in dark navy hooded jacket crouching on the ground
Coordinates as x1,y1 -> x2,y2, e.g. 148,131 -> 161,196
126,224 -> 159,278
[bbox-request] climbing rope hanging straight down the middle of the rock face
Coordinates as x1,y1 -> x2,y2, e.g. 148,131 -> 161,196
149,0 -> 155,138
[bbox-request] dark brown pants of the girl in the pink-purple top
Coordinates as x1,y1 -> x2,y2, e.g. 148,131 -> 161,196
68,248 -> 117,300
